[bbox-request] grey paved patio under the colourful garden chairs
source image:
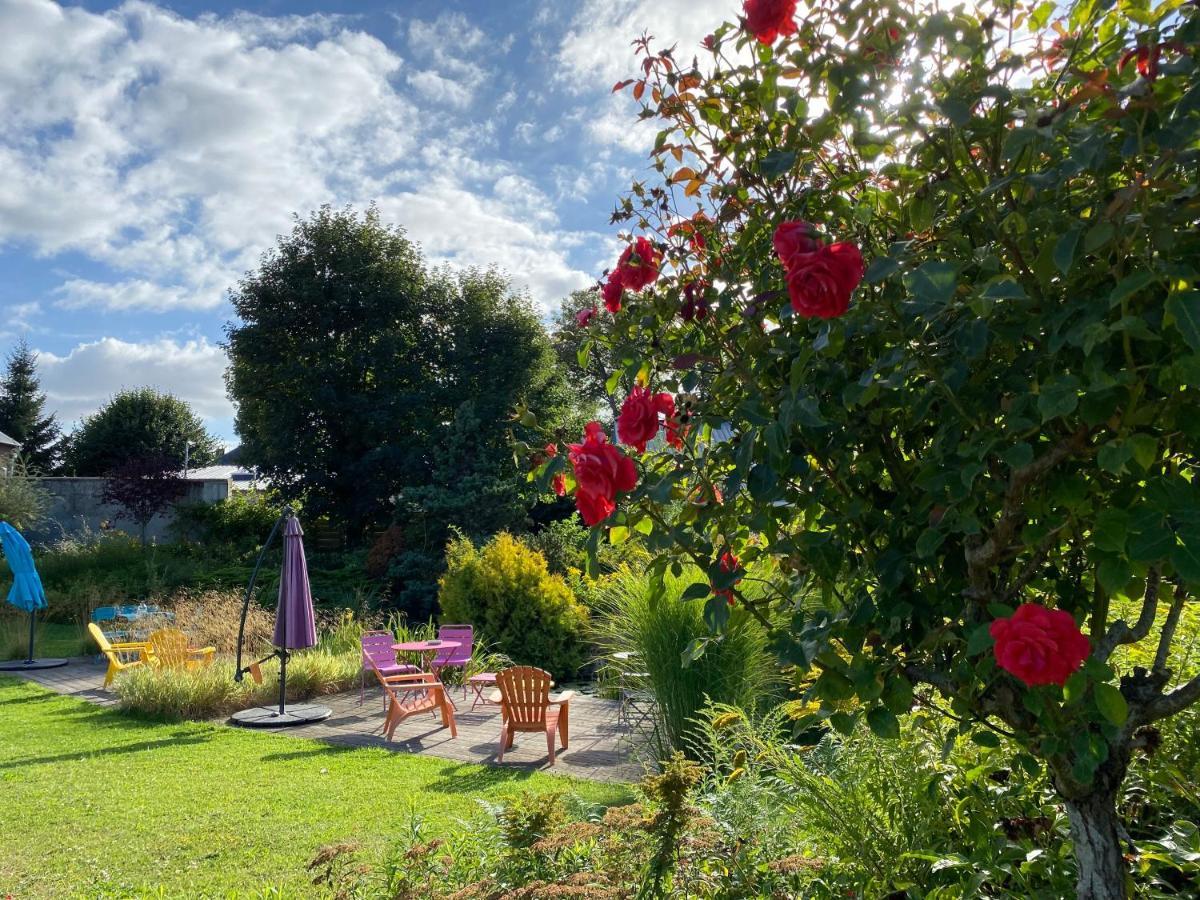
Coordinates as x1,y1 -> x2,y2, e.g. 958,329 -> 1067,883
9,658 -> 642,781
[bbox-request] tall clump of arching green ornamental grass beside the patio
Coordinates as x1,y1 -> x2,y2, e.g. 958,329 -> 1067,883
593,569 -> 778,760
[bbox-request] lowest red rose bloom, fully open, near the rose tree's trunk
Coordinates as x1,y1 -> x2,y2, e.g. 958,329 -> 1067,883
988,604 -> 1092,686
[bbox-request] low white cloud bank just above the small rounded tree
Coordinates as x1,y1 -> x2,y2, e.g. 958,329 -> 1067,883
38,337 -> 233,437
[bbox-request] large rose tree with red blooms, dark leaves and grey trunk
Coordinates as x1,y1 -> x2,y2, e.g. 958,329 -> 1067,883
532,0 -> 1200,898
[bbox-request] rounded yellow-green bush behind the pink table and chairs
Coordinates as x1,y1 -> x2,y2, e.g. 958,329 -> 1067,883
438,533 -> 588,680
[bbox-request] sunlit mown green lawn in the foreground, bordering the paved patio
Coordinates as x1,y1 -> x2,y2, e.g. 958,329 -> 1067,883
0,677 -> 629,900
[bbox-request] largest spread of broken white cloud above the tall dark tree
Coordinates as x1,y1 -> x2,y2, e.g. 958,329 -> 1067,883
0,0 -> 604,321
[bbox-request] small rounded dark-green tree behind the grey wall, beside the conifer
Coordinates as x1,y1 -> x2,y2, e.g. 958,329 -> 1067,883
64,388 -> 220,475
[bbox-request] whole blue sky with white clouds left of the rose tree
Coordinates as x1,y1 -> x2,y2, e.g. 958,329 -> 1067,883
0,0 -> 724,443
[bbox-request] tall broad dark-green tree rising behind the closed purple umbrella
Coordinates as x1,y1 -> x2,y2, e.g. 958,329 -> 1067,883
228,208 -> 585,554
